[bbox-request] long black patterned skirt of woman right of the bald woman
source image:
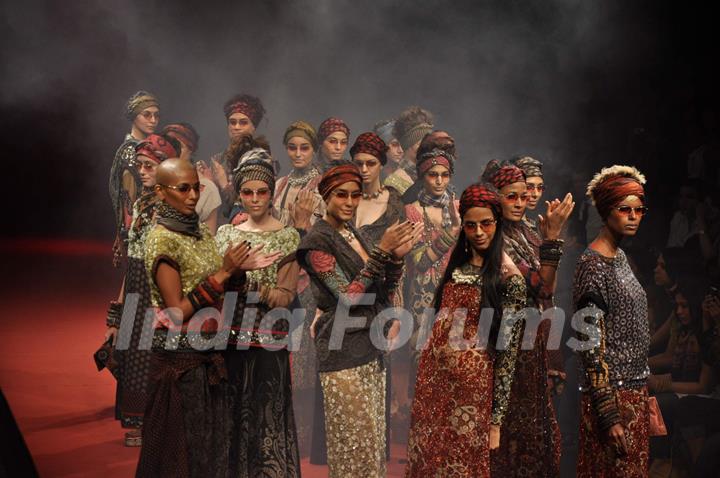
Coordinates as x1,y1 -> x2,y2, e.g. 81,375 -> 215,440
225,347 -> 300,478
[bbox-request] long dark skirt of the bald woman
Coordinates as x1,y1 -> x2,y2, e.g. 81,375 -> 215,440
136,351 -> 231,478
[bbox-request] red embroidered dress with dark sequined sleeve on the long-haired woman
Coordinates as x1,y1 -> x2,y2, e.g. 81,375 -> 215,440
406,264 -> 526,478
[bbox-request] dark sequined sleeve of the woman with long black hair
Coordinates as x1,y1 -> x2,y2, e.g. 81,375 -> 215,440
490,274 -> 527,425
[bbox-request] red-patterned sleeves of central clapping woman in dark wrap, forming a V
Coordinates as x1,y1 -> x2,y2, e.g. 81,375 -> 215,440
307,247 -> 390,307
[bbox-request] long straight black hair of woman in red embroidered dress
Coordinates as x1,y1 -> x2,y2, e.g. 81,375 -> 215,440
433,208 -> 504,346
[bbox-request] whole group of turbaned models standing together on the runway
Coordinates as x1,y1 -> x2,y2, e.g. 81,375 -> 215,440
106,91 -> 651,478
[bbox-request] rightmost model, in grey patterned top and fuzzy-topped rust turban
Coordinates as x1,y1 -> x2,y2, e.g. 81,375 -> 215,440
573,165 -> 650,478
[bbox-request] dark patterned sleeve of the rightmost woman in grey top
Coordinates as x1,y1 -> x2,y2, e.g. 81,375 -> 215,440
574,259 -> 620,430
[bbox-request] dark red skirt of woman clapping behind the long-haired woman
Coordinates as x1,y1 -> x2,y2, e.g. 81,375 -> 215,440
491,321 -> 561,478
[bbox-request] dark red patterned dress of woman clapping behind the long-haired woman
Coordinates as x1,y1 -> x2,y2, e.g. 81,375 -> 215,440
492,222 -> 561,477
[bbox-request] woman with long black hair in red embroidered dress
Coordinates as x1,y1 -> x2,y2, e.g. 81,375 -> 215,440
406,184 -> 526,478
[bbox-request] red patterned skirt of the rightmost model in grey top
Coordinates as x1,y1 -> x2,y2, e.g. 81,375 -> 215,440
576,387 -> 650,478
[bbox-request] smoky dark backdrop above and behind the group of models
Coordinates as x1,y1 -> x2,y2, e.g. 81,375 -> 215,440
0,0 -> 717,241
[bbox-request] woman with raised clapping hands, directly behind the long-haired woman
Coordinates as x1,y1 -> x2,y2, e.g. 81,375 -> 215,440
483,160 -> 574,477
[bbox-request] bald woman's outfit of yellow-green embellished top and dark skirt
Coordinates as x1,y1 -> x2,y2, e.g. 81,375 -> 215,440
136,218 -> 233,478
